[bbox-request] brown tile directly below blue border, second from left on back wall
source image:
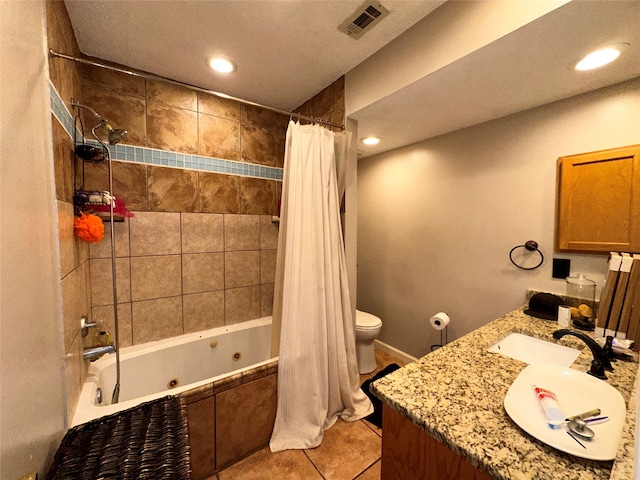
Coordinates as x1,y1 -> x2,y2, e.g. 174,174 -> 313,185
148,167 -> 198,212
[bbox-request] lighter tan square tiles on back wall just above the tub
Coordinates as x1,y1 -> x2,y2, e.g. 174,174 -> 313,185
89,212 -> 278,346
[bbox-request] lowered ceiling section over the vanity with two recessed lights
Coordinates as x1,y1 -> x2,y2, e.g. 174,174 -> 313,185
350,1 -> 640,158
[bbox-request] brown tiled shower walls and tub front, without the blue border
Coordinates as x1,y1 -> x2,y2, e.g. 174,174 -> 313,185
46,0 -> 344,472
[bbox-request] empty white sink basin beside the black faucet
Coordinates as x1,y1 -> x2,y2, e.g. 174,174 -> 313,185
488,332 -> 580,367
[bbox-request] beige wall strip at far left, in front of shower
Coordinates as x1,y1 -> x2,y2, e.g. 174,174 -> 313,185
0,1 -> 65,480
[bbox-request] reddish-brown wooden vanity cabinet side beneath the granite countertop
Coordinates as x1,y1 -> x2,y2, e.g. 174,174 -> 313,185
380,403 -> 491,480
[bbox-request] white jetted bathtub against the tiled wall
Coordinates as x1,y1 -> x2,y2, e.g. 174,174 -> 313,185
71,317 -> 273,427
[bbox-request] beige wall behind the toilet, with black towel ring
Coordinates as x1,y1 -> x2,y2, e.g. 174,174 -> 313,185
358,79 -> 640,356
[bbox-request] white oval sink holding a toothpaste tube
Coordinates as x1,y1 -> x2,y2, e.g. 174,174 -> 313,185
504,365 -> 627,460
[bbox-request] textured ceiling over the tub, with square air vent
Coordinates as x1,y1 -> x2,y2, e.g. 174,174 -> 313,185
65,0 -> 444,110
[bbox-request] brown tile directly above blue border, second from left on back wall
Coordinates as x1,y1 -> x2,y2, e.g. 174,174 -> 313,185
147,103 -> 198,153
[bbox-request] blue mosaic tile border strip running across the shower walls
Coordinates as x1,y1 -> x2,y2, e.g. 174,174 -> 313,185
49,82 -> 283,181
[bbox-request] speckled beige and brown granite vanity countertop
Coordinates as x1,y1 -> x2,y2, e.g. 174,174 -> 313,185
371,309 -> 638,480
